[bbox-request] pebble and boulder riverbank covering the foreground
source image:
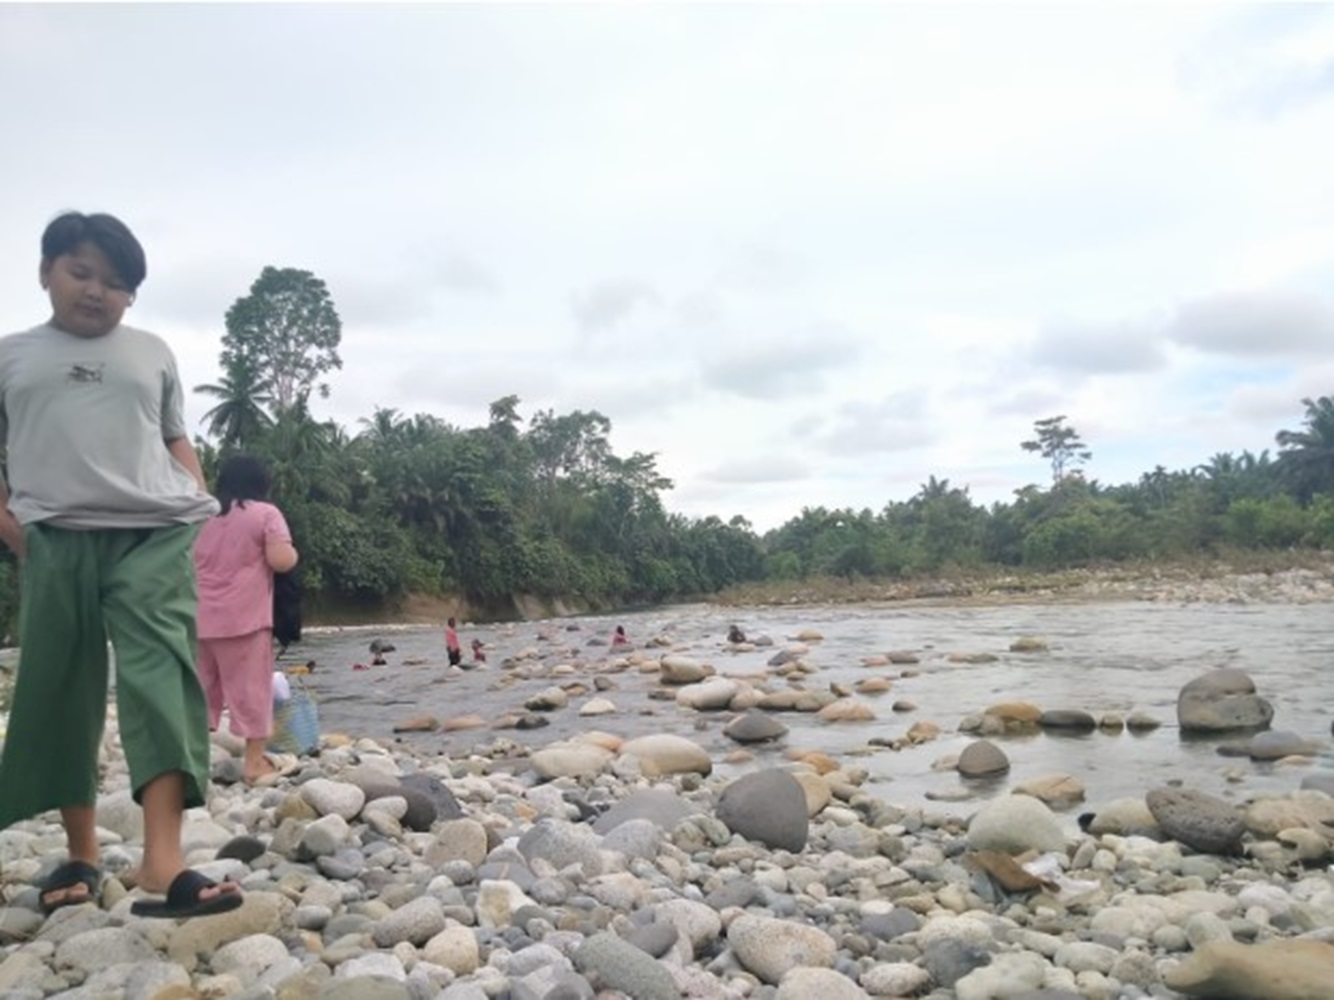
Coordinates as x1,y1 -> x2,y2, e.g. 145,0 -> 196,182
0,570 -> 1334,1000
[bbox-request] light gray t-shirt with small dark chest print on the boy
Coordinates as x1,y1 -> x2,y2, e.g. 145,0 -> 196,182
0,324 -> 217,528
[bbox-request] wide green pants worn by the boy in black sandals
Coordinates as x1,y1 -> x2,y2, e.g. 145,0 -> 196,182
0,524 -> 208,829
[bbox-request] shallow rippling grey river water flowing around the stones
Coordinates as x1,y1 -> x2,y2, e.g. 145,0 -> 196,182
285,603 -> 1334,812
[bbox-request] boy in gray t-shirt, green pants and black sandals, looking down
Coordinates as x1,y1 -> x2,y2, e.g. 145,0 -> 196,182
0,212 -> 241,917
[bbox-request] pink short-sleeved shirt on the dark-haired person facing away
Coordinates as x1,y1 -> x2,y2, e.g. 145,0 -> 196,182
195,500 -> 292,639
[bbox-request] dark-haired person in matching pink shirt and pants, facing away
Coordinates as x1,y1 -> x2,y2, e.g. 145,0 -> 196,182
195,455 -> 297,784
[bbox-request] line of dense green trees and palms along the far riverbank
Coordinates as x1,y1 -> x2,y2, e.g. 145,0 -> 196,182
0,268 -> 1334,634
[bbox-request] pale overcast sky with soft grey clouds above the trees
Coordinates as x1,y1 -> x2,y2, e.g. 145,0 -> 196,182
0,4 -> 1334,531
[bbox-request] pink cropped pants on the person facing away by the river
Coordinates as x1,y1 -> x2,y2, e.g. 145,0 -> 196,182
197,628 -> 273,740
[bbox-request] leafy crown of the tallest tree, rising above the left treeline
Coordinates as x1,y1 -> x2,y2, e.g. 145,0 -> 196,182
223,267 -> 343,411
